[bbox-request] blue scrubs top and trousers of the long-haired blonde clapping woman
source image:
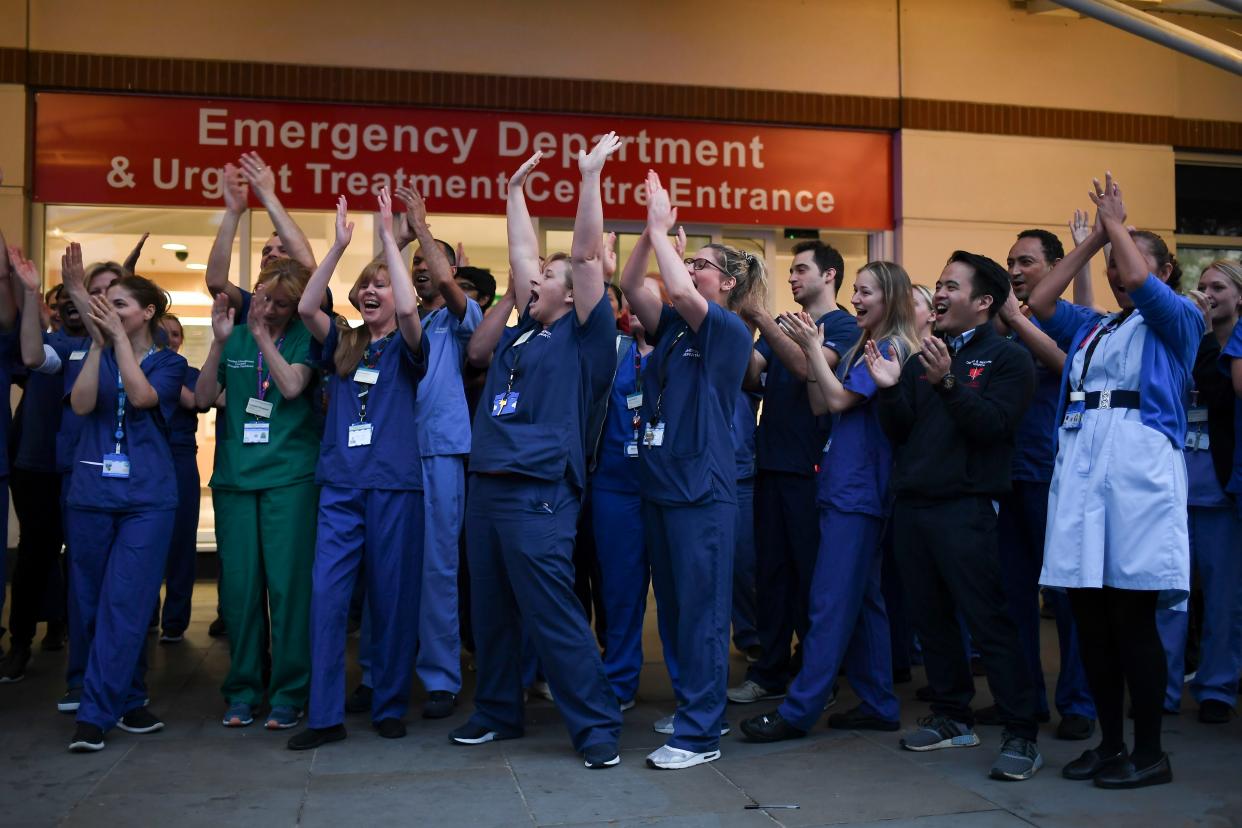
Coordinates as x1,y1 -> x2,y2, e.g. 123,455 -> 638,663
780,343 -> 900,730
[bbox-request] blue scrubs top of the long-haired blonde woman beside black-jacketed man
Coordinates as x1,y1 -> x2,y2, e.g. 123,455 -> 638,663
816,340 -> 893,518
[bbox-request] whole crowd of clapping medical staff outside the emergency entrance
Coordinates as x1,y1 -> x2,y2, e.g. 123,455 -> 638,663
0,139 -> 1242,787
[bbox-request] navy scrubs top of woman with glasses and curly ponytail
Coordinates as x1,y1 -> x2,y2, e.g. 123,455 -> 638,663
638,303 -> 751,505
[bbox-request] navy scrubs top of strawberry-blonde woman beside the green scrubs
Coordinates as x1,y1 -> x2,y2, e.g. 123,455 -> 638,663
314,324 -> 427,492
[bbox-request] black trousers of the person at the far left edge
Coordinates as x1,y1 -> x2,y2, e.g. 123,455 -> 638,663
9,468 -> 65,647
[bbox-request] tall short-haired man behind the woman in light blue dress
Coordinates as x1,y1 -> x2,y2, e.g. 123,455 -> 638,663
993,230 -> 1095,740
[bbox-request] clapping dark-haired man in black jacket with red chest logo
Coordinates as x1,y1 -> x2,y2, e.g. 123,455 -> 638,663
866,251 -> 1043,780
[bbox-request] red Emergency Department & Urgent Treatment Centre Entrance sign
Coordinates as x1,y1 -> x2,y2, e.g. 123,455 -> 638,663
35,93 -> 893,230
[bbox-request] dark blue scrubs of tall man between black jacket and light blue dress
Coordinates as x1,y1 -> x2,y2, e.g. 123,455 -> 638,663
996,307 -> 1095,719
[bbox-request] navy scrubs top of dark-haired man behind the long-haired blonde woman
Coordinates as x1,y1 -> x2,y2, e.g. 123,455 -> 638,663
755,305 -> 858,477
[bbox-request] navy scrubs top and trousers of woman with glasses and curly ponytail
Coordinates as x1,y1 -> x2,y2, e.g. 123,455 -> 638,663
638,303 -> 751,752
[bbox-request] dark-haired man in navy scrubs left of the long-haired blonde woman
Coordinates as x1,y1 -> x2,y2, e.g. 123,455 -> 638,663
728,240 -> 858,704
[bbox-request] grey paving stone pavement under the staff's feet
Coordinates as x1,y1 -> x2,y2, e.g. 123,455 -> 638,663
0,583 -> 1242,828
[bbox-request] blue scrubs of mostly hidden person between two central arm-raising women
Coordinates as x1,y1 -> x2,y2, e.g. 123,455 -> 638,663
591,341 -> 651,701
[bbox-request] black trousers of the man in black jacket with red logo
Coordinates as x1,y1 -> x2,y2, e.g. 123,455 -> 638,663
893,497 -> 1038,739
